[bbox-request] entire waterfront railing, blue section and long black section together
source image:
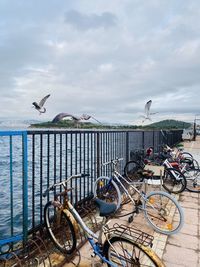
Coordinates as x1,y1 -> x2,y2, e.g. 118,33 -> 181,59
0,130 -> 182,254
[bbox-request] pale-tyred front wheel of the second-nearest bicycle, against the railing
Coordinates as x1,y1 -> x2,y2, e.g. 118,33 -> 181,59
94,176 -> 121,209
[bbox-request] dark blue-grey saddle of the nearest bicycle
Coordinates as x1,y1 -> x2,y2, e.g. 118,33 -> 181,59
94,198 -> 117,217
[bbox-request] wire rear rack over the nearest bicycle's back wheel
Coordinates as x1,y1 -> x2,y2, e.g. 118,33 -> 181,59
105,223 -> 154,247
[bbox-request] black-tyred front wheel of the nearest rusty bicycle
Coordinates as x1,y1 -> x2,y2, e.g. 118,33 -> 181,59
44,201 -> 76,254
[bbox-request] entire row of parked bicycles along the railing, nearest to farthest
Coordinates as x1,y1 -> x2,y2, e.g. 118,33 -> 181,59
40,146 -> 199,267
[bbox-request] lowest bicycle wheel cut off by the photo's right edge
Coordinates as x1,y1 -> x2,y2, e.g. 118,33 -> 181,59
184,169 -> 200,193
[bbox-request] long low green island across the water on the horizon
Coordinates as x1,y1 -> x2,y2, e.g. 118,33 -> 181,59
30,120 -> 192,130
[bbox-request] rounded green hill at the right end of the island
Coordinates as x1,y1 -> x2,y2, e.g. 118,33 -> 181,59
142,120 -> 192,130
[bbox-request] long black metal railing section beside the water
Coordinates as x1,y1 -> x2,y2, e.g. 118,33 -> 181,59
0,130 -> 182,254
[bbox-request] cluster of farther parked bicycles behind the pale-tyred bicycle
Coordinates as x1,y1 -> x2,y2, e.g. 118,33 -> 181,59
124,145 -> 200,193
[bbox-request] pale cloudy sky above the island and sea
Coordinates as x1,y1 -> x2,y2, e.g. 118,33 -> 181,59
0,0 -> 200,124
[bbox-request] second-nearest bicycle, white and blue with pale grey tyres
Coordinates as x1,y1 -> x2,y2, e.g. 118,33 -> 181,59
94,159 -> 184,235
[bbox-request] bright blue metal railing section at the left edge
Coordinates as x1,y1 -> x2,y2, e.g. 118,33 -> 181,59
0,131 -> 28,252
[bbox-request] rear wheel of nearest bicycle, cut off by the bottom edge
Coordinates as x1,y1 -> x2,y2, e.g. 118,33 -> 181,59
103,236 -> 164,267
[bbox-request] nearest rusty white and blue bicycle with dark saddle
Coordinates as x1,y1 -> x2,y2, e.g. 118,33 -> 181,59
43,174 -> 165,267
